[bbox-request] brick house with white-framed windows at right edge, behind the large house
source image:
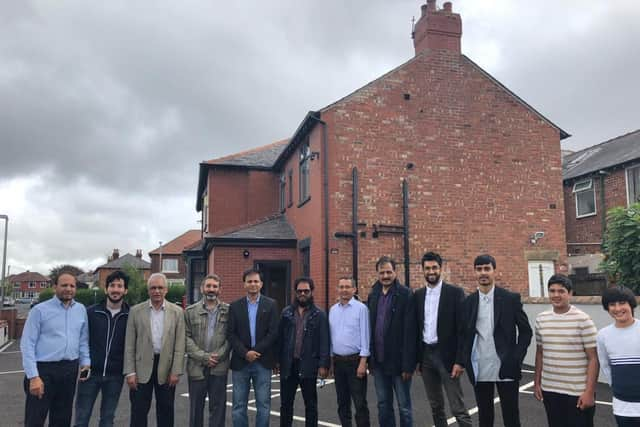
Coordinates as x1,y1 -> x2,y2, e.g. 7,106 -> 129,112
563,130 -> 640,274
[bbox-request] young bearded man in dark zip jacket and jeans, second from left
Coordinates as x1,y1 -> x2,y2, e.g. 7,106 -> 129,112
75,270 -> 129,427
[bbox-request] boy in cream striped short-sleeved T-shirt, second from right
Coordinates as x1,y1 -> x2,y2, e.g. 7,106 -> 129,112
534,275 -> 598,427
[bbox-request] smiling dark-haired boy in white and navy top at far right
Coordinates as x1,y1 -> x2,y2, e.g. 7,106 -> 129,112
598,286 -> 640,427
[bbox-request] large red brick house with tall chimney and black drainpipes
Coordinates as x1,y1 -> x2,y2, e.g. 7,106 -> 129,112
196,0 -> 569,307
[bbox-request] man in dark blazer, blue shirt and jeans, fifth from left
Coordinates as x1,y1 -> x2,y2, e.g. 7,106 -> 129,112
227,269 -> 278,427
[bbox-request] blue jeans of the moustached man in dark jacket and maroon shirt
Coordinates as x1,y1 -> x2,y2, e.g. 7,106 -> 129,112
373,369 -> 413,427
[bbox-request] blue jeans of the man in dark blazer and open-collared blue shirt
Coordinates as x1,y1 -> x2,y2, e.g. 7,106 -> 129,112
231,362 -> 271,427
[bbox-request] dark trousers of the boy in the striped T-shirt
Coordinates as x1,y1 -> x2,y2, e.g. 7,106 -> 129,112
542,391 -> 596,427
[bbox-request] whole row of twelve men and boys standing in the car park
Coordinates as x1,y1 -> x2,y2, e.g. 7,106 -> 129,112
21,252 -> 640,427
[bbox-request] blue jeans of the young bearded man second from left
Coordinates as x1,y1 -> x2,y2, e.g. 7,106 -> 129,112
75,374 -> 124,427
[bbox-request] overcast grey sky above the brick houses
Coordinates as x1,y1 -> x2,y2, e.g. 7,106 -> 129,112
0,0 -> 640,273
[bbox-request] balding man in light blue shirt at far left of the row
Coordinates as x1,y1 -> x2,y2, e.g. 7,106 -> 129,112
20,269 -> 91,427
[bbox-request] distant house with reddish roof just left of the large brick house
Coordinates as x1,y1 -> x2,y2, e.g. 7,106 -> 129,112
149,230 -> 202,286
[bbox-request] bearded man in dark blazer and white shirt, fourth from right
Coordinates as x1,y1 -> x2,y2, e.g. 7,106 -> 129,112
414,252 -> 471,427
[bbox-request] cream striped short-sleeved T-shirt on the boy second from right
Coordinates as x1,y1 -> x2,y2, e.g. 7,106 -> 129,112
535,306 -> 598,396
